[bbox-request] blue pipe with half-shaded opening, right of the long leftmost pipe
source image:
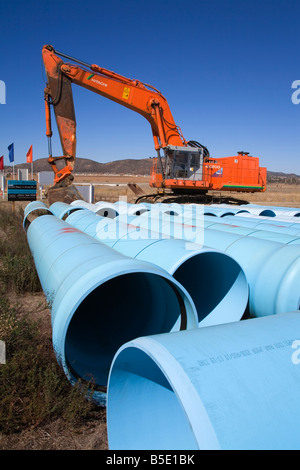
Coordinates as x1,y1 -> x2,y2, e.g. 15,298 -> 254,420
66,212 -> 248,327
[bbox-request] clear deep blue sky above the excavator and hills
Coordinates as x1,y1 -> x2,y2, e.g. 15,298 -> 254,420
0,0 -> 300,174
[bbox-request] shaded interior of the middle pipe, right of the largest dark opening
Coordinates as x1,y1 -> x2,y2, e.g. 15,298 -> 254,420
173,252 -> 242,322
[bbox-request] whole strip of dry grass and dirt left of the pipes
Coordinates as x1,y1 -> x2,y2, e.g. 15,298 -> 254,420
0,203 -> 107,450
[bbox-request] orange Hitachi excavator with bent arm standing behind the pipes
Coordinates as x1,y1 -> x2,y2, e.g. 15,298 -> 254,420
42,45 -> 267,202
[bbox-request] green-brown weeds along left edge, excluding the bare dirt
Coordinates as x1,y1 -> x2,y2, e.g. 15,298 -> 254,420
0,209 -> 99,435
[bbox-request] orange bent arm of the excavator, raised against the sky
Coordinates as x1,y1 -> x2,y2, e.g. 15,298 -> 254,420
42,45 -> 192,186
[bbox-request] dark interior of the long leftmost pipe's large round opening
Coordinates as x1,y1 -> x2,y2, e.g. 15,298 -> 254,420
65,272 -> 186,387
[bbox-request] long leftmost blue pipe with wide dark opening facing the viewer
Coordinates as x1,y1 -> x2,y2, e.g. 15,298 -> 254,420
27,211 -> 198,402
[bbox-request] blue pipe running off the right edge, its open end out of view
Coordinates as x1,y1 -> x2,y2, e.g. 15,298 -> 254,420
130,214 -> 300,316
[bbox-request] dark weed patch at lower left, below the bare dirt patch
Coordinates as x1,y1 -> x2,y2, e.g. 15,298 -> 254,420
0,293 -> 93,434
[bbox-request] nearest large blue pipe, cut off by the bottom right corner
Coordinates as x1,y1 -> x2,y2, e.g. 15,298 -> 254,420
107,312 -> 300,451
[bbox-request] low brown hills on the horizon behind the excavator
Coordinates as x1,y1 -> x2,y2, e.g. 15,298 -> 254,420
5,158 -> 300,184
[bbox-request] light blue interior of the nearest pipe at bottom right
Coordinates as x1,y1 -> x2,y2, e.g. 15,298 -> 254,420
107,347 -> 200,450
